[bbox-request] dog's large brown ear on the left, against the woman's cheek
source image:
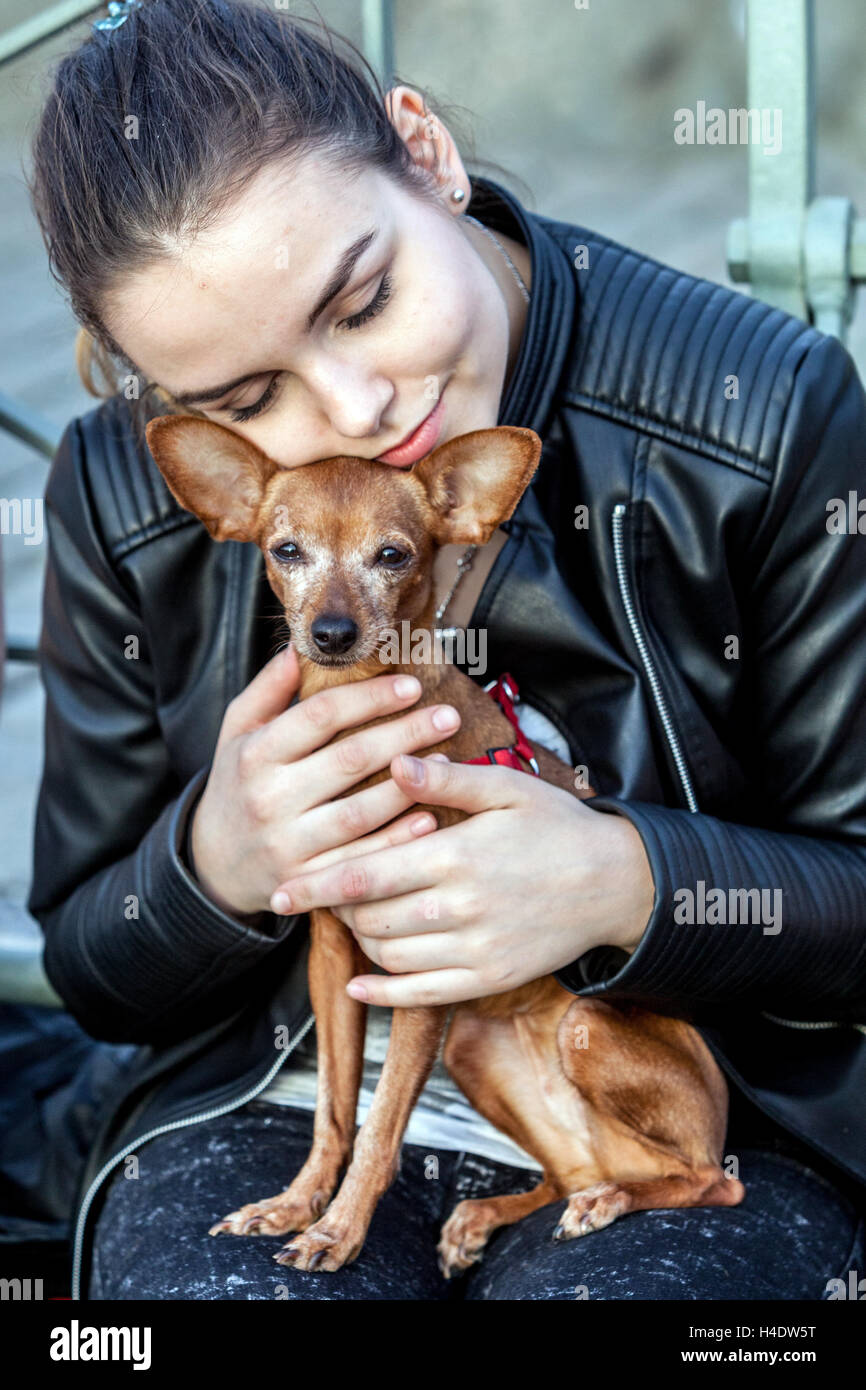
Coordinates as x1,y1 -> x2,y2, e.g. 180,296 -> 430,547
145,416 -> 277,541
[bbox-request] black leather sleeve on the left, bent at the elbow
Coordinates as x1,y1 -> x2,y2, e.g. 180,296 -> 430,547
28,421 -> 303,1044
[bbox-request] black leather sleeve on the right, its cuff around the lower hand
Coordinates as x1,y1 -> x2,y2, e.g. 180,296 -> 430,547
556,336 -> 866,1023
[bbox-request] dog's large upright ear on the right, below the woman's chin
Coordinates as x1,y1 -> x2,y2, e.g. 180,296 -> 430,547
411,425 -> 541,545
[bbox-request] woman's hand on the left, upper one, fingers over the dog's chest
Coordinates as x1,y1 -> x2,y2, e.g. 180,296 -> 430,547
190,648 -> 460,916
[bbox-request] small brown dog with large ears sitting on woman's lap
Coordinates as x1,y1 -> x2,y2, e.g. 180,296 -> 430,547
147,416 -> 745,1276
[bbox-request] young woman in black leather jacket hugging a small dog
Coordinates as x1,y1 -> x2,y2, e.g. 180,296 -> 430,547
31,0 -> 866,1300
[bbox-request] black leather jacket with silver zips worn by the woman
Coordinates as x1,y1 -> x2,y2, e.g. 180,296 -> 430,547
29,179 -> 866,1287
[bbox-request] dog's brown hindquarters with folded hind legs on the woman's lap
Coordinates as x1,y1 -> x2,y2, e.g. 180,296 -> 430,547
439,981 -> 745,1275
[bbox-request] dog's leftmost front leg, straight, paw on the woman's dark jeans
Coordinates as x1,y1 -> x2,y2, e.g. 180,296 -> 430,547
210,908 -> 367,1236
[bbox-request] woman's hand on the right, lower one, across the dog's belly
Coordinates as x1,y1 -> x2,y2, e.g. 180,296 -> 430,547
271,758 -> 655,1006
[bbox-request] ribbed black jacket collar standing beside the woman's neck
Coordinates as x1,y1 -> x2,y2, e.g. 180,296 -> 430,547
470,177 -> 578,439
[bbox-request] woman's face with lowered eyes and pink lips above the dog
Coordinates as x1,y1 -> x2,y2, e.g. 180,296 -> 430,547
106,144 -> 528,468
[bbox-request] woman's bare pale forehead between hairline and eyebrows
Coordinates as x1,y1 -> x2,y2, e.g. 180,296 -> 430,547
106,156 -> 395,391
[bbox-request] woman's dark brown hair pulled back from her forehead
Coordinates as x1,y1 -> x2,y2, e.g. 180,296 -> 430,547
28,0 -> 525,447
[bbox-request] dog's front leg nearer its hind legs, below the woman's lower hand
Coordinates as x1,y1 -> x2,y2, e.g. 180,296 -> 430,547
274,1005 -> 449,1270
